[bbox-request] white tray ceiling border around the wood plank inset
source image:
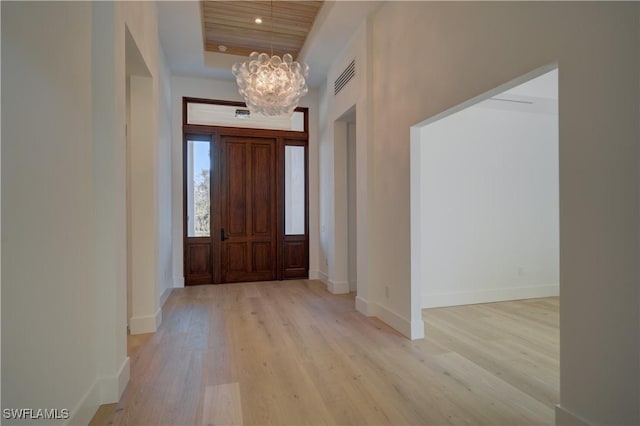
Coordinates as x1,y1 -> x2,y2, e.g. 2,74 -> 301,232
157,1 -> 382,87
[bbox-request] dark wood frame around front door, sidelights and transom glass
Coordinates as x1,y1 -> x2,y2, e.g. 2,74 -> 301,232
182,97 -> 309,286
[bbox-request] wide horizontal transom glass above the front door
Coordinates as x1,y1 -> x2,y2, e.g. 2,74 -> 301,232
187,102 -> 304,132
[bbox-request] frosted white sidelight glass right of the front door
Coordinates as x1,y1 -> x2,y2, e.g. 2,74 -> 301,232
284,146 -> 305,235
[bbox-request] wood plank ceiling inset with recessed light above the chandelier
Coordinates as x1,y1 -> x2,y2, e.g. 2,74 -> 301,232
200,0 -> 323,58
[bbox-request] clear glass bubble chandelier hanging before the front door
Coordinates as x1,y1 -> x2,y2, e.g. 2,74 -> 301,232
231,2 -> 309,116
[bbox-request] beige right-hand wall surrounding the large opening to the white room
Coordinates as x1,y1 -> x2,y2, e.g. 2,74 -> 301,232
370,2 -> 640,424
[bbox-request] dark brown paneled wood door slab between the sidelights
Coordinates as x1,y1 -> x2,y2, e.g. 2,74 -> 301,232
219,136 -> 278,282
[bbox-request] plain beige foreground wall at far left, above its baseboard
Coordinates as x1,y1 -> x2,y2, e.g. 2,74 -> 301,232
0,2 -> 99,424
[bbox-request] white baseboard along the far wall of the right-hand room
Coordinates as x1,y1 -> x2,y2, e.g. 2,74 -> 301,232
422,284 -> 560,308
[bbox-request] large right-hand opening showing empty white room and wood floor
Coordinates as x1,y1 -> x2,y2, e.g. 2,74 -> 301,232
411,64 -> 560,413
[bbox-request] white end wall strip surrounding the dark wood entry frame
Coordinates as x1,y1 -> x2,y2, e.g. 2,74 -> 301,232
171,76 -> 319,287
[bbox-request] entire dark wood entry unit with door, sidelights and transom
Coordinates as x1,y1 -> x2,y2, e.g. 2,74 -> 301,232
183,98 -> 309,285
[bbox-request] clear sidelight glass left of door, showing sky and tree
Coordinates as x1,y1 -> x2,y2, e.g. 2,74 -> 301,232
187,140 -> 211,237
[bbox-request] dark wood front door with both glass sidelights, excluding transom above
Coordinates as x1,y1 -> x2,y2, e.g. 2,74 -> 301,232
184,129 -> 308,285
